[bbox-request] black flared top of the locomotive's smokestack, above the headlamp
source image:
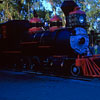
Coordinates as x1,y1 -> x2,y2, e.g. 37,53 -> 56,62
61,0 -> 78,17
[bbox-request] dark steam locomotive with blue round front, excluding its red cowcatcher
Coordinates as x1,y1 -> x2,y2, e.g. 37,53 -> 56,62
0,0 -> 89,75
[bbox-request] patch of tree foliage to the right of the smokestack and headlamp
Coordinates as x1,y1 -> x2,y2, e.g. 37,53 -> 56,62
75,0 -> 100,31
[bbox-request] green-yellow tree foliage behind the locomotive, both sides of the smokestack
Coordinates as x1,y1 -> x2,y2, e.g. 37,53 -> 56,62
0,0 -> 100,29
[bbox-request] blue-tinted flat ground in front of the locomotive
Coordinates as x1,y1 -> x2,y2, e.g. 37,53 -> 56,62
0,71 -> 100,100
